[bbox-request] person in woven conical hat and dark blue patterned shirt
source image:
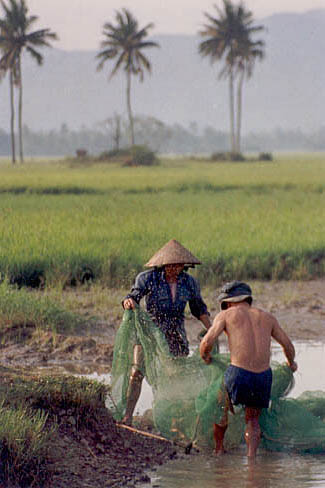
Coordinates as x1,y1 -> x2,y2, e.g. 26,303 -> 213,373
122,239 -> 211,424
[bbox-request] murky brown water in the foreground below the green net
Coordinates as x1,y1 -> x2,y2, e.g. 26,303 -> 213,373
140,447 -> 325,488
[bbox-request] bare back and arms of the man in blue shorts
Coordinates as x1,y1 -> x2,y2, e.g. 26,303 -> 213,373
200,302 -> 295,373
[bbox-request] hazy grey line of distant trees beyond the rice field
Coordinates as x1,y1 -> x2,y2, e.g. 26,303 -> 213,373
0,116 -> 325,157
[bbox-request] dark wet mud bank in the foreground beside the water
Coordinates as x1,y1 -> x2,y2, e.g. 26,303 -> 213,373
46,413 -> 178,488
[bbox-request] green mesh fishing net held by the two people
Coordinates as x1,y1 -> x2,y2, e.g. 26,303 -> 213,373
110,307 -> 325,453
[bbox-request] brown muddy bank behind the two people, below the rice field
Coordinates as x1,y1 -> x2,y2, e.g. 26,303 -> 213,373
0,280 -> 325,374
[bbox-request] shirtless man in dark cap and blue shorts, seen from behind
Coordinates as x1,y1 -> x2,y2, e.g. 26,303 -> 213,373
200,281 -> 297,457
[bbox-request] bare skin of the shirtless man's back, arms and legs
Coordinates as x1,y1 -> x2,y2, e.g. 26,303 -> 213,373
200,301 -> 297,458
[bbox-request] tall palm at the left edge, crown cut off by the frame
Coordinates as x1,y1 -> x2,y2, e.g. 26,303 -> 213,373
0,0 -> 57,162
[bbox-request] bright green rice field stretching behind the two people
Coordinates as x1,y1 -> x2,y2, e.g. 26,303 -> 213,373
0,154 -> 325,287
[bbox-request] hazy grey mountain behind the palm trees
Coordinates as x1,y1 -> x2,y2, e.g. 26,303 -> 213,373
0,9 -> 325,133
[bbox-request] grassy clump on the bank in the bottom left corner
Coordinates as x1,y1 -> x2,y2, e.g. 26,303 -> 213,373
0,371 -> 107,487
